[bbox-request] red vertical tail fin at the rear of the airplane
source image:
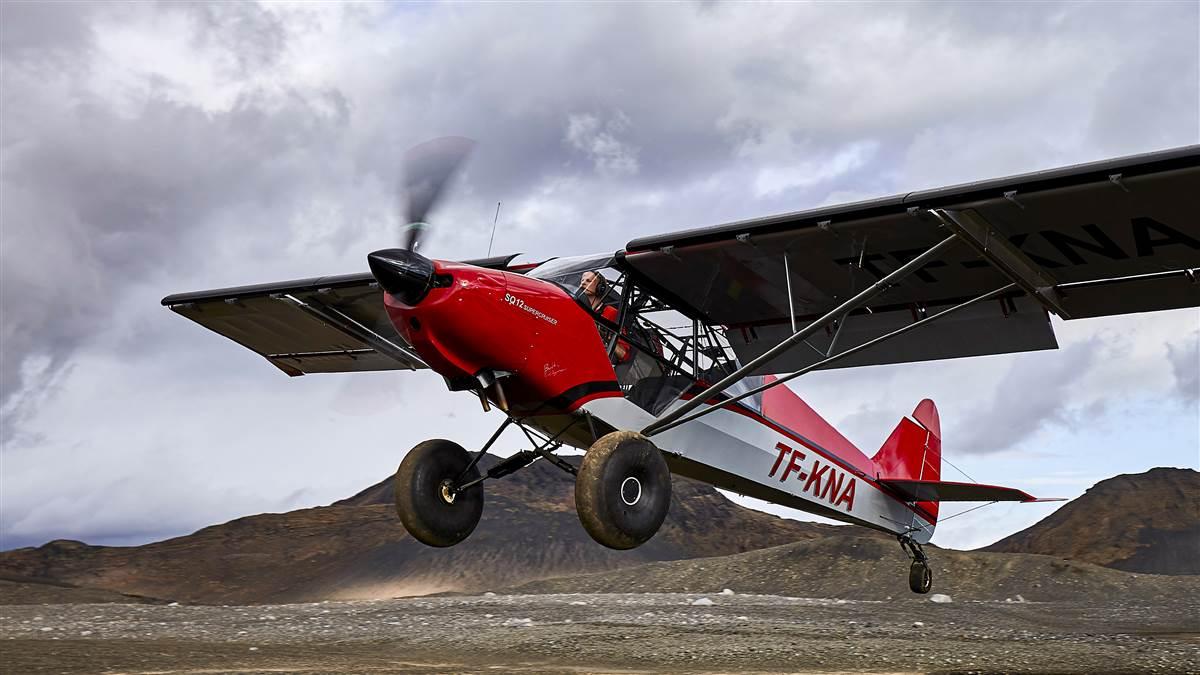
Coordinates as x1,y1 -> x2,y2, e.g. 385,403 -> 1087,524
871,399 -> 942,521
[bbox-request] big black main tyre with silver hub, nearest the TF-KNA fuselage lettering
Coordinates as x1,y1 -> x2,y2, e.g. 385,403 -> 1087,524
575,431 -> 671,550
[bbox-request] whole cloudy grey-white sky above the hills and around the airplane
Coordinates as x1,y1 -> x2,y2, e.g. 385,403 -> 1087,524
0,1 -> 1200,549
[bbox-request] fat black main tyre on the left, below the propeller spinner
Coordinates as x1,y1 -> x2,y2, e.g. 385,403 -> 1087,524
396,438 -> 484,546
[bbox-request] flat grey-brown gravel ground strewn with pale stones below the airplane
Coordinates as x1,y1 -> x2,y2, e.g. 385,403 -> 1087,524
0,593 -> 1200,674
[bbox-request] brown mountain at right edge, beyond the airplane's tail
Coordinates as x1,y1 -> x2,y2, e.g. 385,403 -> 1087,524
983,468 -> 1200,574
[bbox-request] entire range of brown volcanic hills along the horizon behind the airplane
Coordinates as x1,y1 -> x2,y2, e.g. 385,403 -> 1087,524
7,456 -> 1200,604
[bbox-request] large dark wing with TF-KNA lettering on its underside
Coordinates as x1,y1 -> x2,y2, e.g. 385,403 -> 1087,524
618,145 -> 1200,374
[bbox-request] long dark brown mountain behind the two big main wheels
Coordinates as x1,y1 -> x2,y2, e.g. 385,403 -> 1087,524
0,456 -> 836,604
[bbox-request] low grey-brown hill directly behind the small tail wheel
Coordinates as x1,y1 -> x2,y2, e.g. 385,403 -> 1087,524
509,530 -> 1200,603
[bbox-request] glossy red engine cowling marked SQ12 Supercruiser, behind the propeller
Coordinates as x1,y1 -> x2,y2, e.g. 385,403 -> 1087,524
372,251 -> 622,414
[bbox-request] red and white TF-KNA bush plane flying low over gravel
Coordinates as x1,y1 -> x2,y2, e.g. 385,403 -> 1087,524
162,138 -> 1200,593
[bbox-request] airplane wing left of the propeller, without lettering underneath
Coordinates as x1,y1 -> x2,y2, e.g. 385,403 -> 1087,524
162,255 -> 516,376
